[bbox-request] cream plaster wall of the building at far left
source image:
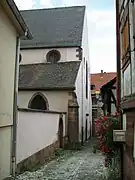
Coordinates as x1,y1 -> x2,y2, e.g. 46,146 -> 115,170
0,6 -> 17,179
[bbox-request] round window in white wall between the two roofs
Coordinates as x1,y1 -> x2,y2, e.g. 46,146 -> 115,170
46,50 -> 61,63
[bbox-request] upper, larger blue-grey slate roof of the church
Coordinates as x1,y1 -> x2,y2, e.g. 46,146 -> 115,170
21,6 -> 85,48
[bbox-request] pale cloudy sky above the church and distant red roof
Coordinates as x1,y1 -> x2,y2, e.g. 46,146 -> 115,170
15,0 -> 116,73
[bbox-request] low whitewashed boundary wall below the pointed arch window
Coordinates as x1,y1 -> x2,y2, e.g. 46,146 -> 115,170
17,111 -> 65,163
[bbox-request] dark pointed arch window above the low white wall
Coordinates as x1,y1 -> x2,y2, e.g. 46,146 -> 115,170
28,93 -> 49,110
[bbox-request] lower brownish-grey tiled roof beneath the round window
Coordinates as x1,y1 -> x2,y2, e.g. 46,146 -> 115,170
19,61 -> 80,90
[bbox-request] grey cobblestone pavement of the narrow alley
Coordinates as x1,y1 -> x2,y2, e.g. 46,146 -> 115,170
17,141 -> 103,180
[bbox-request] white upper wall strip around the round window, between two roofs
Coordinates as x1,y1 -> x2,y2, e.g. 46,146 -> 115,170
21,48 -> 78,64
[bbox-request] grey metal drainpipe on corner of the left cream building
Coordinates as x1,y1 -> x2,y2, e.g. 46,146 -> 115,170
11,37 -> 20,177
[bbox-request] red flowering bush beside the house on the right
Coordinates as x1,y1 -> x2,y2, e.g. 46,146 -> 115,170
95,113 -> 120,166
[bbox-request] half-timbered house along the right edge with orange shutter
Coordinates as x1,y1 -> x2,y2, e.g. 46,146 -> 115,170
116,0 -> 135,180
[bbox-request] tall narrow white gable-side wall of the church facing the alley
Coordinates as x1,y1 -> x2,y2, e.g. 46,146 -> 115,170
76,14 -> 92,140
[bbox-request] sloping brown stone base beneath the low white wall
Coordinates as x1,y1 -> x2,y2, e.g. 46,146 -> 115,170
16,141 -> 59,173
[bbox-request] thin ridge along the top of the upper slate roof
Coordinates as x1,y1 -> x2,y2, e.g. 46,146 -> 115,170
20,5 -> 86,12
